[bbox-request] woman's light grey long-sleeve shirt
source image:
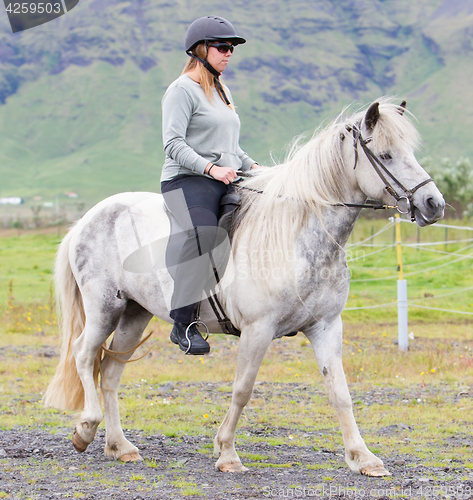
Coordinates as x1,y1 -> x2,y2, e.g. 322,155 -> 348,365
161,75 -> 255,181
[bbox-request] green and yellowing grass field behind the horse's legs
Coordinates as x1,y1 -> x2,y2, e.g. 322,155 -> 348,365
0,220 -> 473,474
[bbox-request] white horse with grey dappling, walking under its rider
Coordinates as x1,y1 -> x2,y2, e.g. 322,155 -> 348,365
44,99 -> 445,476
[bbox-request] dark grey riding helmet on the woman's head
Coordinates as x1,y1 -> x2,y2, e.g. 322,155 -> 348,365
185,16 -> 246,53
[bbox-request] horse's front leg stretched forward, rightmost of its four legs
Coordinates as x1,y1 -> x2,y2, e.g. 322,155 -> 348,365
306,316 -> 390,476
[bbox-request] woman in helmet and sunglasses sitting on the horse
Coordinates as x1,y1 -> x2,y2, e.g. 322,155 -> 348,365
161,16 -> 258,354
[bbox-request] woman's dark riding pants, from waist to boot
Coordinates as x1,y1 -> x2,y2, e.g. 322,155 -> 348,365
161,175 -> 232,324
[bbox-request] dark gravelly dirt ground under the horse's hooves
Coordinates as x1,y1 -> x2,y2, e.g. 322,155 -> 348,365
0,408 -> 473,500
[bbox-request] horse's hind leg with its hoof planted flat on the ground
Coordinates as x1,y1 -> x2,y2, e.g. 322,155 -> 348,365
100,301 -> 153,462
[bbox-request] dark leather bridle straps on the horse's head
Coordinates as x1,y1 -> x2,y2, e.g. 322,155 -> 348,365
346,123 -> 433,222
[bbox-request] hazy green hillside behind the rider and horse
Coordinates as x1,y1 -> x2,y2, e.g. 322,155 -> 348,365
0,0 -> 473,203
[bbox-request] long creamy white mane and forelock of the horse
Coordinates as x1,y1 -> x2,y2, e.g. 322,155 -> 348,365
234,98 -> 419,288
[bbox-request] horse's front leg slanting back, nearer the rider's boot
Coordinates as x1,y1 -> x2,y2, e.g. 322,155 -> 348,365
214,324 -> 272,472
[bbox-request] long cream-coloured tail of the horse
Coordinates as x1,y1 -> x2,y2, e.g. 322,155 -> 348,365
43,229 -> 102,410
